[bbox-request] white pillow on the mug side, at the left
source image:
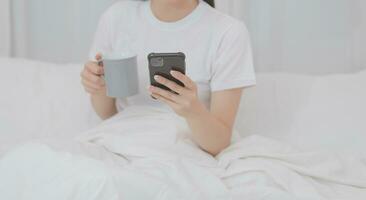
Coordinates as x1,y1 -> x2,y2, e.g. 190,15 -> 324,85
0,58 -> 99,145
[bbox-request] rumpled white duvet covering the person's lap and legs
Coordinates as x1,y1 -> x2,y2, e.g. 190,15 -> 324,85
0,106 -> 366,200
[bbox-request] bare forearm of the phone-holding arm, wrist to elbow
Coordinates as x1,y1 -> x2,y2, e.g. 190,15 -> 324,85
186,104 -> 232,156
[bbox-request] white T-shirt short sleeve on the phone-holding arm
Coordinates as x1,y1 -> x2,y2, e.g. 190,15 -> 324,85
211,22 -> 256,92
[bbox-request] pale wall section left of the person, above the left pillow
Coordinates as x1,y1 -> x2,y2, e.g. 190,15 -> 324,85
12,0 -> 114,62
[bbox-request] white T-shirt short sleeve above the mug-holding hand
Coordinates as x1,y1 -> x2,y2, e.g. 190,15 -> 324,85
89,11 -> 112,60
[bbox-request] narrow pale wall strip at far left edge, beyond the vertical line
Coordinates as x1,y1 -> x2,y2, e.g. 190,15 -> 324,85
0,0 -> 10,56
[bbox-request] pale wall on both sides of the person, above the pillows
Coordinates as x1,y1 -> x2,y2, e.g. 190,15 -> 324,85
5,0 -> 366,74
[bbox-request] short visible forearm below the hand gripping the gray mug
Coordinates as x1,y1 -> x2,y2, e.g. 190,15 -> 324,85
91,95 -> 117,120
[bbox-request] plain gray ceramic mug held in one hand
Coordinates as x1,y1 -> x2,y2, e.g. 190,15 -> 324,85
100,54 -> 138,98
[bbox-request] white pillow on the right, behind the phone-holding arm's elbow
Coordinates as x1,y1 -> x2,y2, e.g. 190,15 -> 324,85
236,71 -> 366,152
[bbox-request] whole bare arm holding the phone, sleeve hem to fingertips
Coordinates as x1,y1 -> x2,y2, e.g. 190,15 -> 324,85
149,71 -> 237,156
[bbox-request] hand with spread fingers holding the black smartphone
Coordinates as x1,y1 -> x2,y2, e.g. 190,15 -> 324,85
149,71 -> 205,118
